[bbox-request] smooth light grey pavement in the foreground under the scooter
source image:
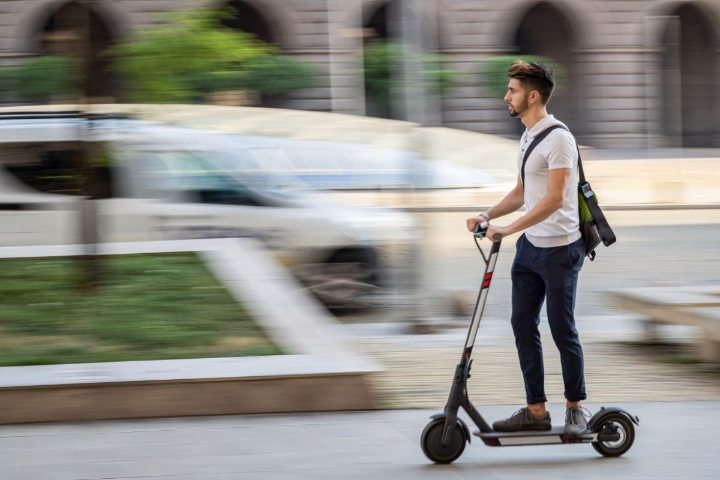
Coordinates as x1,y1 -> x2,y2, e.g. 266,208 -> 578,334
0,401 -> 720,480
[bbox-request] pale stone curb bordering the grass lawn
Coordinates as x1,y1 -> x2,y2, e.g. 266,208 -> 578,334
0,239 -> 378,424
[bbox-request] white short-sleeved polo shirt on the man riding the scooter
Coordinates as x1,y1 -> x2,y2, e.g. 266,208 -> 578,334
517,115 -> 580,248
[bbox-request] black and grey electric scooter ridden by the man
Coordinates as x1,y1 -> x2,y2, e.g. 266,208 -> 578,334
420,222 -> 640,463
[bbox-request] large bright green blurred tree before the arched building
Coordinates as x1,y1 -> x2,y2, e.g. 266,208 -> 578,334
109,9 -> 314,103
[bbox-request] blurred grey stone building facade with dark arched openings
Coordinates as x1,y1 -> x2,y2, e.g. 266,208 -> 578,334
0,0 -> 720,148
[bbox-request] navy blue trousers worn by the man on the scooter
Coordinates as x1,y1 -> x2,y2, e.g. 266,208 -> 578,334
511,235 -> 586,403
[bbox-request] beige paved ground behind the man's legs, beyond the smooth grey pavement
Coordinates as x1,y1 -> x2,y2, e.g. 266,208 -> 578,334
344,316 -> 720,408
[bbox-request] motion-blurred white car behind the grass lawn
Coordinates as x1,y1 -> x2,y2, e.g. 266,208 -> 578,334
0,111 -> 413,308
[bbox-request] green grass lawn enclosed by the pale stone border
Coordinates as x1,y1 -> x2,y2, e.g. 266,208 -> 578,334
0,253 -> 282,366
